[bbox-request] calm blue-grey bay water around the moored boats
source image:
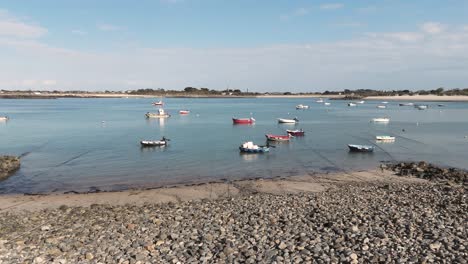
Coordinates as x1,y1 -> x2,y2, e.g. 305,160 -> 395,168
0,98 -> 468,193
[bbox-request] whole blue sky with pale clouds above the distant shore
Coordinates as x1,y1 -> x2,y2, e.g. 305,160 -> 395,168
0,0 -> 468,92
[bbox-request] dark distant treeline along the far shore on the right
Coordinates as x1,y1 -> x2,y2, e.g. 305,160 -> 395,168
322,87 -> 468,97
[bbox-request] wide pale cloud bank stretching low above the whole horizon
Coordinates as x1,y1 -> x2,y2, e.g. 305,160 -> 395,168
0,21 -> 468,91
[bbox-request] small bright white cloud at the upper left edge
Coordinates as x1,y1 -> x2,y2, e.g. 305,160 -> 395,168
0,10 -> 47,38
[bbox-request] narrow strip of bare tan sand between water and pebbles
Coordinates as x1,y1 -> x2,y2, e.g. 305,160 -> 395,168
0,169 -> 426,212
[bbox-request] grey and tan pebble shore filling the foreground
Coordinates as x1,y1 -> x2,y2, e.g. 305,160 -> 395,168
0,179 -> 468,263
